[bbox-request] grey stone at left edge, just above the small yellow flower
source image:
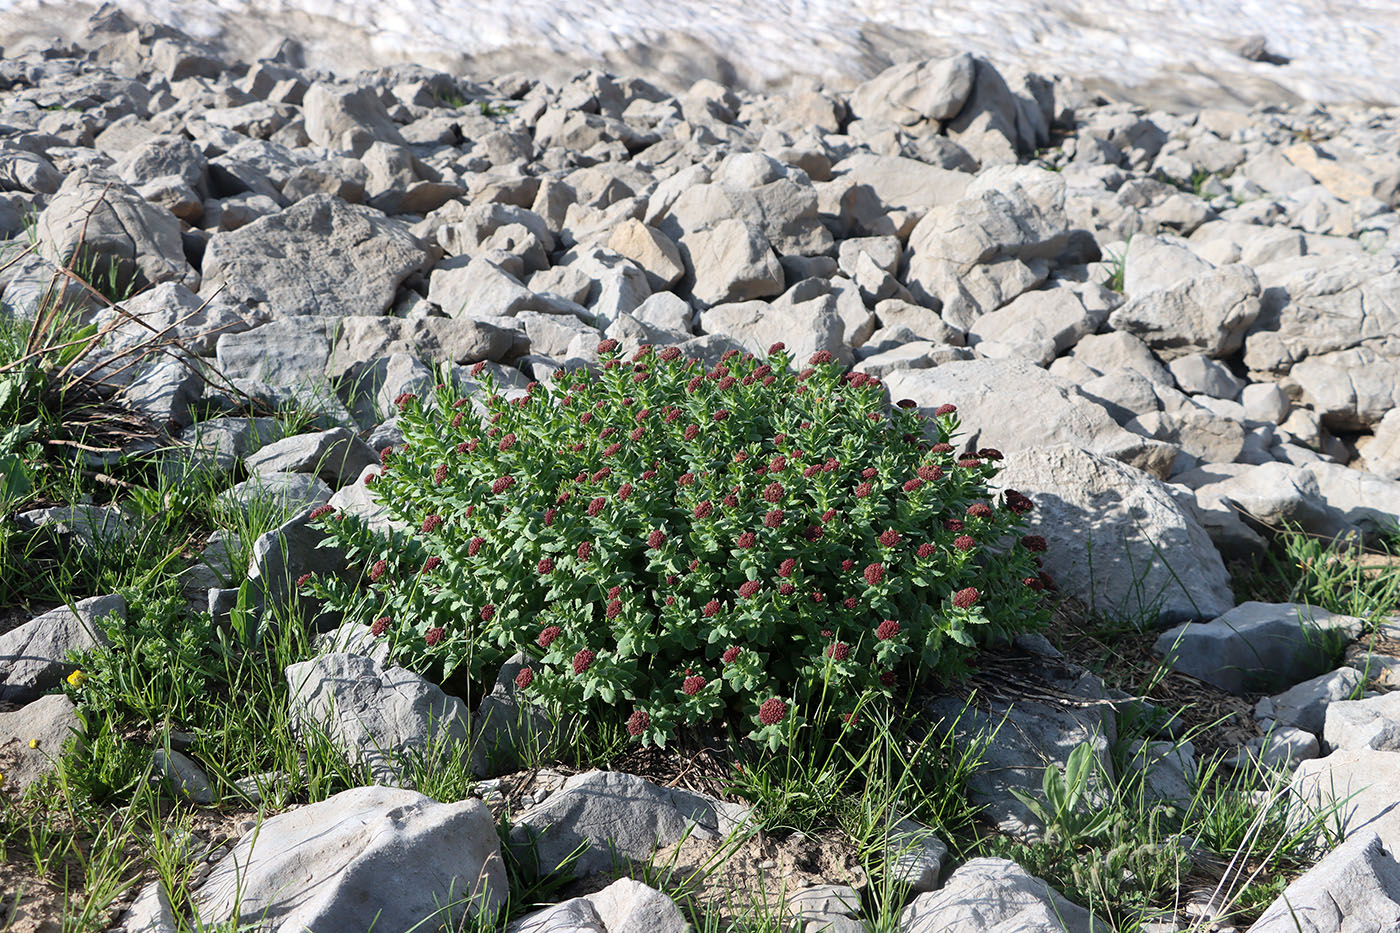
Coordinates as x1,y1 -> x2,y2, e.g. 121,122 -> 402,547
0,595 -> 126,703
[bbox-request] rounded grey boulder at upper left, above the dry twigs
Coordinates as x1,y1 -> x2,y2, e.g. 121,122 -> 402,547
35,172 -> 197,289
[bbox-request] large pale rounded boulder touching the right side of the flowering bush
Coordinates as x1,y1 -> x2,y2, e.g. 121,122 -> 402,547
994,444 -> 1235,623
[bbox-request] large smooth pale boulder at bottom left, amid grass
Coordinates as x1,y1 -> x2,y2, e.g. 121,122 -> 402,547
192,786 -> 510,933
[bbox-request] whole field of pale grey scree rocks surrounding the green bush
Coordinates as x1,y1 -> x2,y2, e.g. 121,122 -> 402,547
0,13 -> 1400,930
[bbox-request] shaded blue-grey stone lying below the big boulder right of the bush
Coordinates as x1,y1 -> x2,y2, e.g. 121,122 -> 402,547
1152,602 -> 1364,696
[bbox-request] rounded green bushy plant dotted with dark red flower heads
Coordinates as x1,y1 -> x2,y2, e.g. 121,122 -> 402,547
308,340 -> 1046,748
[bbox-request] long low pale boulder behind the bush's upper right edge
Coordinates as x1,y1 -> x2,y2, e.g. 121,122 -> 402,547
885,360 -> 1176,479
